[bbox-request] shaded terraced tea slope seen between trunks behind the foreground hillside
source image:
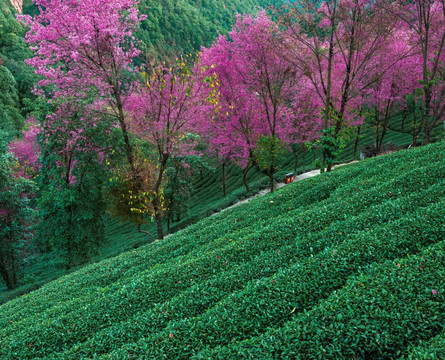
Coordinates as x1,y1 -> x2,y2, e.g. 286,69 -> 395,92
0,107 -> 443,304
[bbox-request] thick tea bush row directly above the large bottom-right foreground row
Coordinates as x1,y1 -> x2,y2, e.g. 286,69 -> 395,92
100,198 -> 445,359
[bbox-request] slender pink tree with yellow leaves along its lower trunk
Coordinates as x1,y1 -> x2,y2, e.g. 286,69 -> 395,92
126,59 -> 202,239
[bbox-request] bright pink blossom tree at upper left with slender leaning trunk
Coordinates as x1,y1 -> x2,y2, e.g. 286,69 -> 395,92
19,0 -> 142,186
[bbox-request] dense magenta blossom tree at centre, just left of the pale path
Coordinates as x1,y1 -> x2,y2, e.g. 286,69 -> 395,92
202,11 -> 298,191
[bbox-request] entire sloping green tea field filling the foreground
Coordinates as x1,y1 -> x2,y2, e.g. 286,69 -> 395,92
0,141 -> 445,359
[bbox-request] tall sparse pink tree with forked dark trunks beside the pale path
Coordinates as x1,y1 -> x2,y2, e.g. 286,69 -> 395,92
280,0 -> 406,171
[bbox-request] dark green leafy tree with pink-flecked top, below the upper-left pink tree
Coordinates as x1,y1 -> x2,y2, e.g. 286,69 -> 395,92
36,104 -> 110,269
